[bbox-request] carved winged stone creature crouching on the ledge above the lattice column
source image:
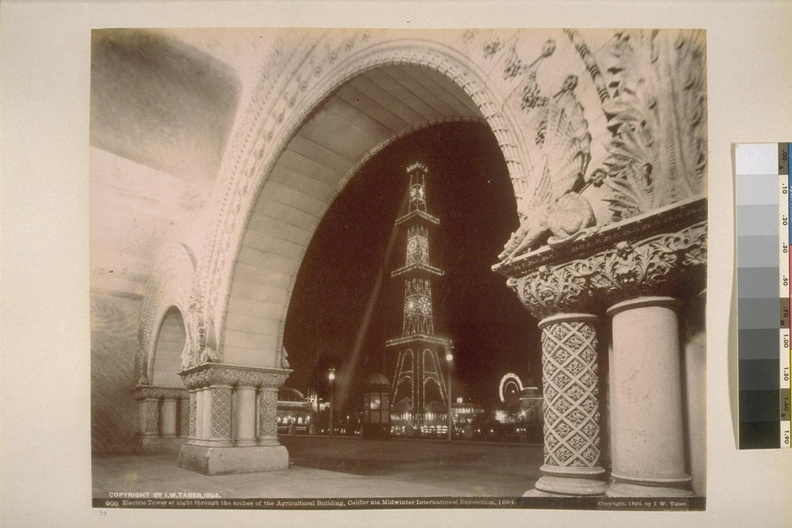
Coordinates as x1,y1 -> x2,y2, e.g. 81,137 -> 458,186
498,75 -> 595,262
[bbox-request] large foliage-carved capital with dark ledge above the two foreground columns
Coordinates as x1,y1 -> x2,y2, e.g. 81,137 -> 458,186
493,199 -> 707,319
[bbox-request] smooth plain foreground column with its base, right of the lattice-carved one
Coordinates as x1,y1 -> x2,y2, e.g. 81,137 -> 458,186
607,297 -> 693,497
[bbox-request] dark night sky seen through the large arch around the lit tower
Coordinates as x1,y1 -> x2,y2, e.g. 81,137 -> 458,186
284,123 -> 541,412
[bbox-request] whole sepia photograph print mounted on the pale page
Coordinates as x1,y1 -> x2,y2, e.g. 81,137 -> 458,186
86,28 -> 708,511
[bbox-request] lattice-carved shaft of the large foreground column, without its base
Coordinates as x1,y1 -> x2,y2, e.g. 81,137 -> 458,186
542,321 -> 600,468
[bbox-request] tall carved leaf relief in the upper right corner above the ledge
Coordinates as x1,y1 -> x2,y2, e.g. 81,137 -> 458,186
600,31 -> 707,219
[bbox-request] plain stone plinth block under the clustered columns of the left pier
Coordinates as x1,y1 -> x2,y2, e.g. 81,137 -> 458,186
179,444 -> 289,475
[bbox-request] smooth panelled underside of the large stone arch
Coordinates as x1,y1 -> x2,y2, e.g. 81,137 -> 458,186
223,64 -> 484,366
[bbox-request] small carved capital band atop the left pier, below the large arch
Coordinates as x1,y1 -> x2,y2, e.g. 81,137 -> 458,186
179,363 -> 292,389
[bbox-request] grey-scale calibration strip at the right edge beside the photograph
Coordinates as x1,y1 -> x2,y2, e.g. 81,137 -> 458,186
735,143 -> 792,449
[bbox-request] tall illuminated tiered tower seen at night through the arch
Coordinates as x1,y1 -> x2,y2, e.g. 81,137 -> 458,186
385,163 -> 451,435
